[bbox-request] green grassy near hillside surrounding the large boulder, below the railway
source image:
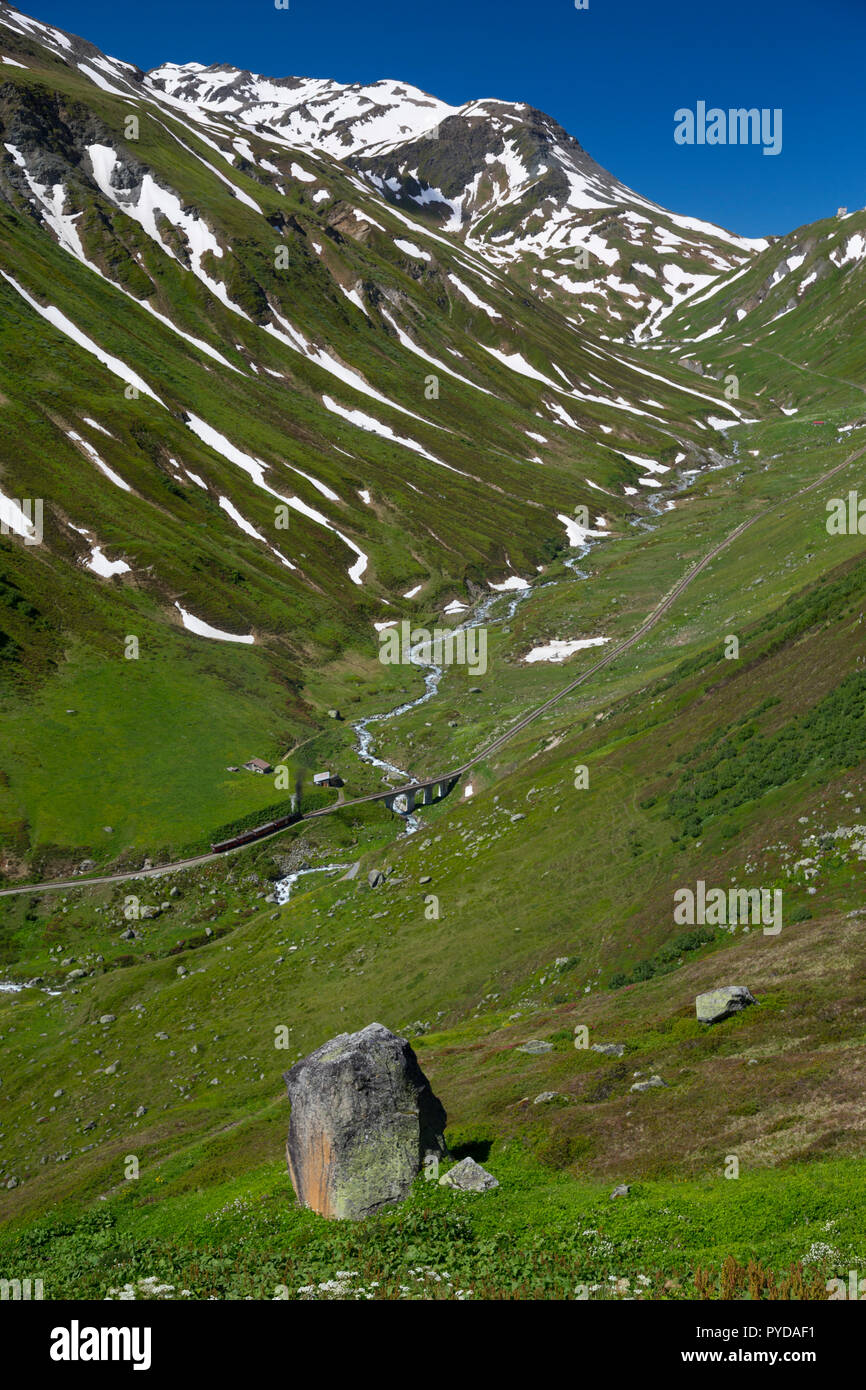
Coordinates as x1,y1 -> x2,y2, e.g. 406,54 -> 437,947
0,400 -> 865,1297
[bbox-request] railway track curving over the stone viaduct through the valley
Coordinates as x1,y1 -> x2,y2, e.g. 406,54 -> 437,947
0,445 -> 866,898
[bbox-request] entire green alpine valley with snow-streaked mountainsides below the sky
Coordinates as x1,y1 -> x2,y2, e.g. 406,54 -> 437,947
0,3 -> 866,1298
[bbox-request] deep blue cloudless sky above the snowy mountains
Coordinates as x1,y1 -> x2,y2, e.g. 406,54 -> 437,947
19,0 -> 866,236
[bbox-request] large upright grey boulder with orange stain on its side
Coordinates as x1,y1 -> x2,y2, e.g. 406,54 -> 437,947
285,1023 -> 448,1220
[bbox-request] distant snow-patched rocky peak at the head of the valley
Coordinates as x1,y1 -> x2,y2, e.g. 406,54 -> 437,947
145,63 -> 767,336
